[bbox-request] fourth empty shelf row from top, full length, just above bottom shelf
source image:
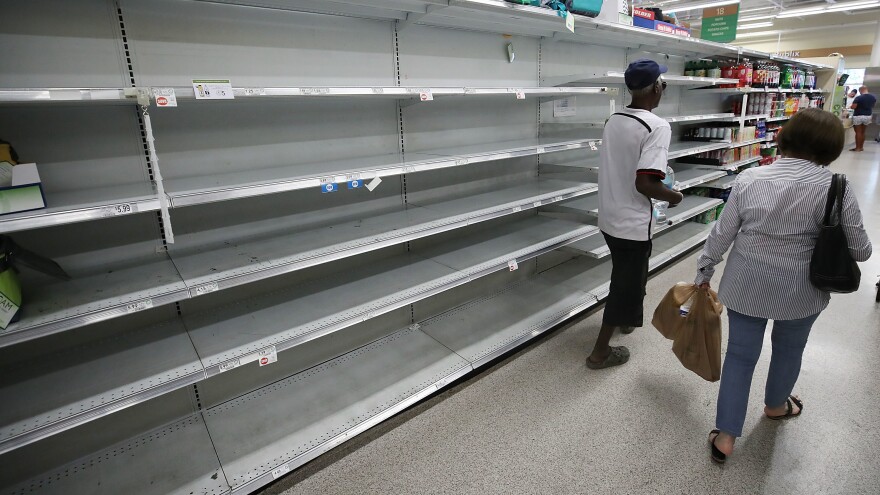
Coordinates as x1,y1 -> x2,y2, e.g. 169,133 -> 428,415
0,216 -> 597,453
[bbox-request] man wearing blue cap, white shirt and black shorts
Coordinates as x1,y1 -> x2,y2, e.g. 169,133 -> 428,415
587,59 -> 683,369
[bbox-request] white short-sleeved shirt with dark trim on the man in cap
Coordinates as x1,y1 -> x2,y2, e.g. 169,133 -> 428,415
599,108 -> 672,241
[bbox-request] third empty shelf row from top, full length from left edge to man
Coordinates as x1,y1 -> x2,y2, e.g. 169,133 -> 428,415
0,179 -> 596,347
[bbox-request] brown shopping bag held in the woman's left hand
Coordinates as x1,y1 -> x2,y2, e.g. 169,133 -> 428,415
653,284 -> 724,382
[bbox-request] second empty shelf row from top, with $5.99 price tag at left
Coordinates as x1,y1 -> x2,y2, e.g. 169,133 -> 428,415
6,139 -> 601,233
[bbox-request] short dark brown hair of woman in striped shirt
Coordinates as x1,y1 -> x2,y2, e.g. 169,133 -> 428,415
778,108 -> 845,165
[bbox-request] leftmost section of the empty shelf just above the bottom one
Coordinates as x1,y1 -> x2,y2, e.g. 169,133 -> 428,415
0,320 -> 205,454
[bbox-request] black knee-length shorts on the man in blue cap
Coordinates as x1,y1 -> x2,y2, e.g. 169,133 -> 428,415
602,232 -> 651,327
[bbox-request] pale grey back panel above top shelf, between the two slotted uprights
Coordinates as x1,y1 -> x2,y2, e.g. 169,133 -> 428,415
122,0 -> 396,87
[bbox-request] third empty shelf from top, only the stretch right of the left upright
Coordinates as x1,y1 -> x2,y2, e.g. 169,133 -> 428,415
171,179 -> 596,296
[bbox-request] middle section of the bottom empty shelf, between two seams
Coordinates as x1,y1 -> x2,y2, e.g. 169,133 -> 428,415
204,328 -> 471,493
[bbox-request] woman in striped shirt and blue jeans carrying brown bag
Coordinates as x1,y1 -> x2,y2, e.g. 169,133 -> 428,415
696,108 -> 871,462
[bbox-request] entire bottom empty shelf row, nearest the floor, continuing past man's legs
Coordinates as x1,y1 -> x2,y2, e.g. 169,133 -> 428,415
1,217 -> 711,494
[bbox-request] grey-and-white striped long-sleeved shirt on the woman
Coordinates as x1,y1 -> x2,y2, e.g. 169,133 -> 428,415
695,158 -> 871,320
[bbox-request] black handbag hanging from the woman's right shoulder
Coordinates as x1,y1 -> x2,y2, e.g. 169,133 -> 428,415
810,174 -> 862,294
